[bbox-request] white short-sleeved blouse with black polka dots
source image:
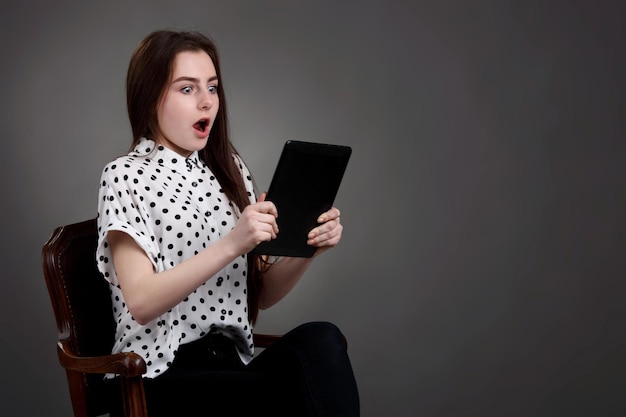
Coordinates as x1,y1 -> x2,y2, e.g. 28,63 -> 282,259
96,138 -> 254,378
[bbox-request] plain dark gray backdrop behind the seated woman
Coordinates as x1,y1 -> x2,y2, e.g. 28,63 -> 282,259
0,0 -> 626,417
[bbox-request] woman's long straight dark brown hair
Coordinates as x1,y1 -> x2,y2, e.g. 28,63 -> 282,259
126,30 -> 263,323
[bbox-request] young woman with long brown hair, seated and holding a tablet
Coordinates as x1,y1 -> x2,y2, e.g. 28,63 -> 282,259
97,31 -> 359,417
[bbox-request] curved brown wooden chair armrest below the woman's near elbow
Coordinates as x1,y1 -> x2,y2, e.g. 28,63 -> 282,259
57,339 -> 146,377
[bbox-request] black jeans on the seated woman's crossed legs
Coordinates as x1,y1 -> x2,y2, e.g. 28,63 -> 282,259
109,322 -> 360,417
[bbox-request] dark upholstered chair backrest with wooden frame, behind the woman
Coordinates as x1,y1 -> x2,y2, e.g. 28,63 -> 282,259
43,219 -> 115,416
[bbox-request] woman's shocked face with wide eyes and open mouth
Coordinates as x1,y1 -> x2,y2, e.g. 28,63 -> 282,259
155,51 -> 220,157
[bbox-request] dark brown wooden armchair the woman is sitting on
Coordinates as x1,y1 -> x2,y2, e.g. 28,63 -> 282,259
42,219 -> 279,417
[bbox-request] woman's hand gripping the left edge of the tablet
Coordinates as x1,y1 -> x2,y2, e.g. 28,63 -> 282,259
228,193 -> 278,254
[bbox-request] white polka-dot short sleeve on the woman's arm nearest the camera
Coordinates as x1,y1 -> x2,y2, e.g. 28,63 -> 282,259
96,160 -> 160,285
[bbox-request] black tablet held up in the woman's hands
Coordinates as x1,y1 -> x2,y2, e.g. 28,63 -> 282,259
252,140 -> 352,258
